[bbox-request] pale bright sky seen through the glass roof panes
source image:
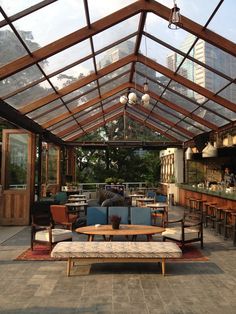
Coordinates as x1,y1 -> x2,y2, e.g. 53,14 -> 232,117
0,0 -> 236,84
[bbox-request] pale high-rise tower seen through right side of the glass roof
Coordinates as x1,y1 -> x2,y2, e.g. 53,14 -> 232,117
167,34 -> 236,103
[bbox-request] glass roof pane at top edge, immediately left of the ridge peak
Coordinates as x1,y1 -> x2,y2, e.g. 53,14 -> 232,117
88,0 -> 136,23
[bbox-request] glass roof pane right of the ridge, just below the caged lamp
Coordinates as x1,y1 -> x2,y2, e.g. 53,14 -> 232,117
145,12 -> 196,53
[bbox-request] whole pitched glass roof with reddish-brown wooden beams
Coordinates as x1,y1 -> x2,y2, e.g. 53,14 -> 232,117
0,0 -> 236,144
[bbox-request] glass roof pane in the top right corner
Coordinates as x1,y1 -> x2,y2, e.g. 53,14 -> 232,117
208,0 -> 236,42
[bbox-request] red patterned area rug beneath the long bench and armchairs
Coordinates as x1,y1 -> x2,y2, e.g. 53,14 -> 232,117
15,245 -> 209,262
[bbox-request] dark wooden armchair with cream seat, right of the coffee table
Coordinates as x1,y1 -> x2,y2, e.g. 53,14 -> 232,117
162,215 -> 203,249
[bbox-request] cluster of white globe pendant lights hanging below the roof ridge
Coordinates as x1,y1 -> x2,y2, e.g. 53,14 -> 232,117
120,29 -> 150,106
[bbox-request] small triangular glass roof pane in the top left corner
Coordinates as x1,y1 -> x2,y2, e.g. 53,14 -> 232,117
0,0 -> 41,16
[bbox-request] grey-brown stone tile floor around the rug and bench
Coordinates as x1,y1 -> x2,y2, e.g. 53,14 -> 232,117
0,207 -> 236,314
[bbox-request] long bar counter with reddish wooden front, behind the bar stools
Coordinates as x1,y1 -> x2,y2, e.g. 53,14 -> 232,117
177,184 -> 236,209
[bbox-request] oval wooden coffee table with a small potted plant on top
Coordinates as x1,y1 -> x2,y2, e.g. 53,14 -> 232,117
75,225 -> 165,241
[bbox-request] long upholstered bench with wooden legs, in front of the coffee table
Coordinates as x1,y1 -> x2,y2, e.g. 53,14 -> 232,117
51,241 -> 182,276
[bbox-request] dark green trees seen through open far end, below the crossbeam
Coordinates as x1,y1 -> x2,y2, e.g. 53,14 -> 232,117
76,147 -> 160,185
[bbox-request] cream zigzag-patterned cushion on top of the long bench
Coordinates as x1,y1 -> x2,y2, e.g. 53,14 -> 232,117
51,242 -> 182,259
